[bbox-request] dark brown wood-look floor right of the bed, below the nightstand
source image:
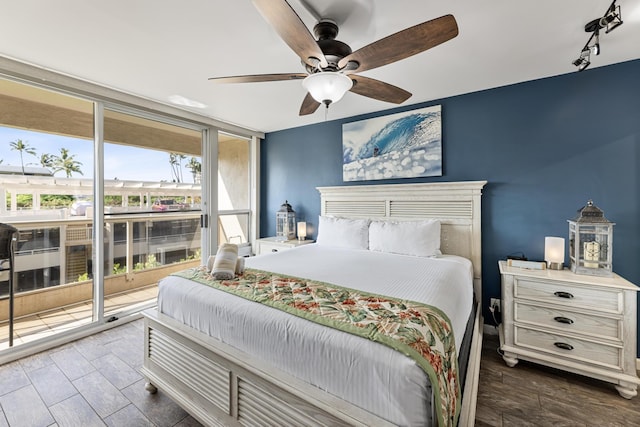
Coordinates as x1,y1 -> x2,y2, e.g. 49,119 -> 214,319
476,334 -> 640,427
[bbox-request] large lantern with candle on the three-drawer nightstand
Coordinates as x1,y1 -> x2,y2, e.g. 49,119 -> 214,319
568,200 -> 615,277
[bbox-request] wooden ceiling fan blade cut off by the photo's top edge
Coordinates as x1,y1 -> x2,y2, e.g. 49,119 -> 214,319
253,0 -> 327,67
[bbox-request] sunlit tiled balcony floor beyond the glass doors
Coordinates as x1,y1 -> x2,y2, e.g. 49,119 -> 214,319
0,284 -> 158,350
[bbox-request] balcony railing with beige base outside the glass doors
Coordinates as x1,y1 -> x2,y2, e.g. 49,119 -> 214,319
0,211 -> 201,322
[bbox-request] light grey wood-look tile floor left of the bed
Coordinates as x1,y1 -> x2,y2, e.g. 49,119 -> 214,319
0,320 -> 200,427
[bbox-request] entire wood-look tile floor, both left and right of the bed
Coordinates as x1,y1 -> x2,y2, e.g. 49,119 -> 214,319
0,320 -> 640,427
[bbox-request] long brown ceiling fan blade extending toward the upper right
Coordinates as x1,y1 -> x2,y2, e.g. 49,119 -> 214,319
338,15 -> 458,72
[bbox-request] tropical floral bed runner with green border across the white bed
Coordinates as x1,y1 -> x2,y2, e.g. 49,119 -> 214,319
173,266 -> 461,426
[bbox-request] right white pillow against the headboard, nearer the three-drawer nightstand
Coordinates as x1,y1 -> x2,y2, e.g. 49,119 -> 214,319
369,220 -> 442,257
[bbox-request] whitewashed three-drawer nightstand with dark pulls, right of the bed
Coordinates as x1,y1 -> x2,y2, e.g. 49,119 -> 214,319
498,261 -> 640,399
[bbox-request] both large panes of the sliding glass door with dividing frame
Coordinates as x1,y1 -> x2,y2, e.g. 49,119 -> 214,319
0,79 -> 206,351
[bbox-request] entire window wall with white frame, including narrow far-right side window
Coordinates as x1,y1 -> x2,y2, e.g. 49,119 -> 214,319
0,57 -> 261,363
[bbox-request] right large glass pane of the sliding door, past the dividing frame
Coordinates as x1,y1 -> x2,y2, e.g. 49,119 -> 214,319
103,109 -> 202,316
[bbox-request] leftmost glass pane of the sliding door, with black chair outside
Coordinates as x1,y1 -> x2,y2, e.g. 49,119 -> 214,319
0,79 -> 94,349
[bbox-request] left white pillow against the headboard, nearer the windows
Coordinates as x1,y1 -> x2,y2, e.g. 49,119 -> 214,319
316,216 -> 369,249
